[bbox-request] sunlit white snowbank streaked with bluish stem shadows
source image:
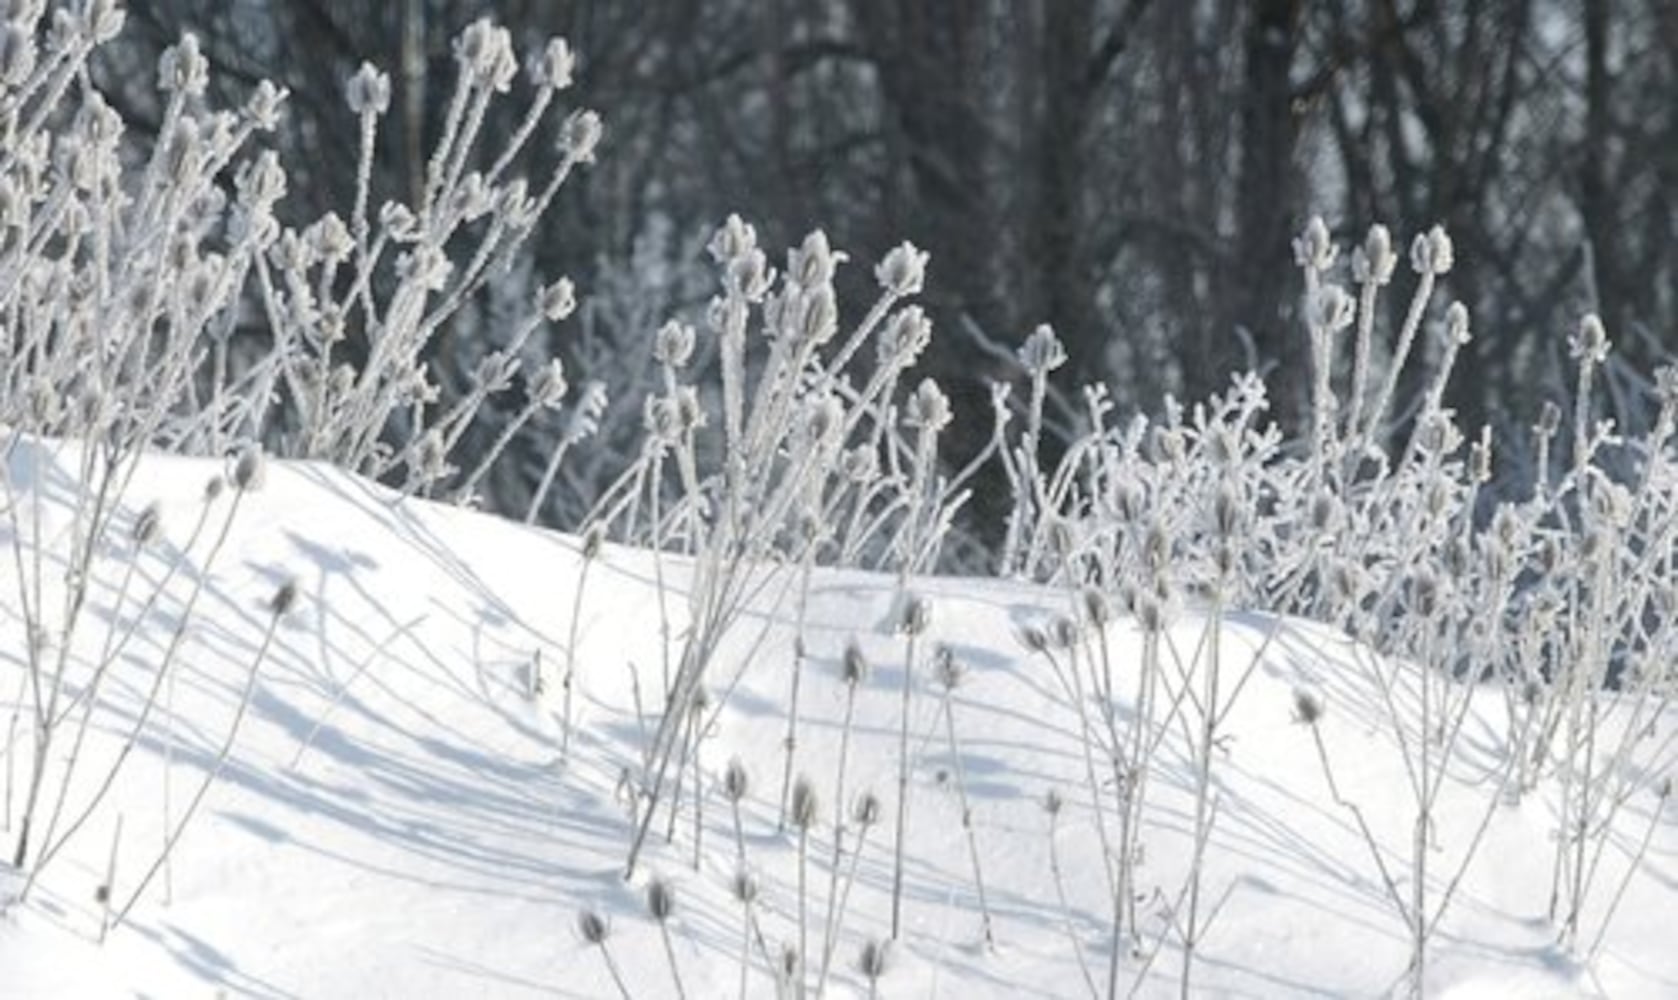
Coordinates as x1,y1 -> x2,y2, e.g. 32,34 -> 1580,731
0,441 -> 1678,1000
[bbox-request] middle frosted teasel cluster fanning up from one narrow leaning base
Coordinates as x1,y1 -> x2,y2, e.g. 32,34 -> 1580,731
624,216 -> 965,872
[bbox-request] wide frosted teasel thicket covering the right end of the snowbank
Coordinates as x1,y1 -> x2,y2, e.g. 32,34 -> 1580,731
998,220 -> 1678,987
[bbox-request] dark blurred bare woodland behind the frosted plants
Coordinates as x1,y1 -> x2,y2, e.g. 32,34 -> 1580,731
101,0 -> 1678,540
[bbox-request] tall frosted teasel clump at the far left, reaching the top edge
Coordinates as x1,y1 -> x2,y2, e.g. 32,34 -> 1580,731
0,0 -> 601,919
